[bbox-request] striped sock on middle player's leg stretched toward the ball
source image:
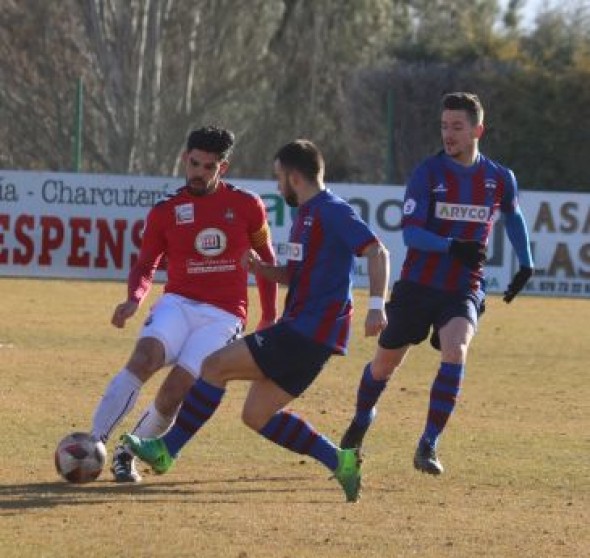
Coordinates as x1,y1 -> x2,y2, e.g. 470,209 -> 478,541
162,378 -> 225,456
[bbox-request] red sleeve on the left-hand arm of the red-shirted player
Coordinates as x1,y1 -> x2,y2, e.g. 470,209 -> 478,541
127,208 -> 166,304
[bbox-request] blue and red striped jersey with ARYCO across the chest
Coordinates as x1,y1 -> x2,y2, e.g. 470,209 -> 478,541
401,151 -> 518,291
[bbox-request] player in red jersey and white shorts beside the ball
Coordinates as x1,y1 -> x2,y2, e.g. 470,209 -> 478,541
92,127 -> 277,482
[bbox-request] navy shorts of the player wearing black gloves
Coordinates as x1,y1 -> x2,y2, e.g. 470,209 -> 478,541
379,280 -> 485,349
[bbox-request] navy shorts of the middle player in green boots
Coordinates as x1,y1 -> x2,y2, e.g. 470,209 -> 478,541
244,322 -> 333,397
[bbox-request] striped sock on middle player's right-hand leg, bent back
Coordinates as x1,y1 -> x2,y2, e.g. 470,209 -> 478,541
258,411 -> 338,471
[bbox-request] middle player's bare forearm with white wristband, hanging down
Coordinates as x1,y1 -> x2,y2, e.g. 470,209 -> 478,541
362,241 -> 389,337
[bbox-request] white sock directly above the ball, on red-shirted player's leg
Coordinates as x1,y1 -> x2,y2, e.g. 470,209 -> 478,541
92,368 -> 143,442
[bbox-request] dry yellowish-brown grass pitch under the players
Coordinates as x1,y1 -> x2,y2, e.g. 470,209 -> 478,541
0,278 -> 590,558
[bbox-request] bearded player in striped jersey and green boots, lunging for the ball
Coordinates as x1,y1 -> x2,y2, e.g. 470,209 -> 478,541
123,139 -> 389,502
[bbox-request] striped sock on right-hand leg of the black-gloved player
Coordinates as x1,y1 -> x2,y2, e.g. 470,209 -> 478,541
422,362 -> 465,447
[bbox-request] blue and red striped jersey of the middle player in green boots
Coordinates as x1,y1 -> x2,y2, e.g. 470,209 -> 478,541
281,190 -> 377,354
